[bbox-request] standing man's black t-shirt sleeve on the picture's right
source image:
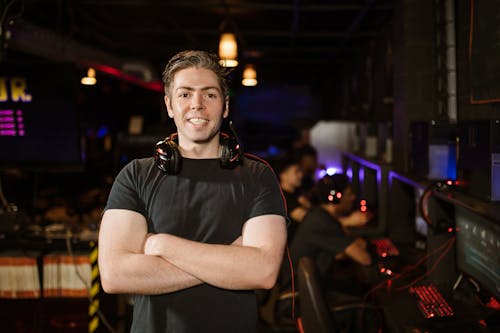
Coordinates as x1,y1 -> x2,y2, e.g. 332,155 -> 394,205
249,164 -> 286,218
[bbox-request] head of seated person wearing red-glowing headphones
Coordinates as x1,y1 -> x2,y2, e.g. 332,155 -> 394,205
315,174 -> 356,214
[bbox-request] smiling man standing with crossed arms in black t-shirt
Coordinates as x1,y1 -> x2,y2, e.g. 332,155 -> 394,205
99,51 -> 286,333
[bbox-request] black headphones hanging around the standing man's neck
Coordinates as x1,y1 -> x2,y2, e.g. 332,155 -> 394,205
154,132 -> 242,175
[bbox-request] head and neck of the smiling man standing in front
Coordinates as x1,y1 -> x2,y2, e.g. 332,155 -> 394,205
163,51 -> 229,151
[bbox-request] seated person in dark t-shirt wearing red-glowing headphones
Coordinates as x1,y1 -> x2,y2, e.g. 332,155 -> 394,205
279,175 -> 372,293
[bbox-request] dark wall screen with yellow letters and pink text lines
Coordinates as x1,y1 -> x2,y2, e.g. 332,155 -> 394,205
0,63 -> 82,171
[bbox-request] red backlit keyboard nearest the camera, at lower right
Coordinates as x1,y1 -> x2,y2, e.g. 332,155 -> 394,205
408,284 -> 453,318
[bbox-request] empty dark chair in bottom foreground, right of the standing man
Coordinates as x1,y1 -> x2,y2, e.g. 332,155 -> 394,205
298,257 -> 380,333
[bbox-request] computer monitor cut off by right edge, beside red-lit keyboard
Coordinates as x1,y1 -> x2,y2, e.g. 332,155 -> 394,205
455,206 -> 500,300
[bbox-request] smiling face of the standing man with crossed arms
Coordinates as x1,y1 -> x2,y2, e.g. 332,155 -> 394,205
165,67 -> 228,147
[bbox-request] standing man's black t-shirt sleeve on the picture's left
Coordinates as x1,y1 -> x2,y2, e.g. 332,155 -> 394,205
104,161 -> 146,216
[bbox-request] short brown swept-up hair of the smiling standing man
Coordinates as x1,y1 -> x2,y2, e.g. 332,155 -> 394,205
162,50 -> 229,99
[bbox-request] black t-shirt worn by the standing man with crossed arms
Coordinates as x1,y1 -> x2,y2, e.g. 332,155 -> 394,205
106,158 -> 285,333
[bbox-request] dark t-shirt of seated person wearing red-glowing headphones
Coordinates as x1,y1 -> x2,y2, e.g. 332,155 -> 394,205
280,206 -> 353,291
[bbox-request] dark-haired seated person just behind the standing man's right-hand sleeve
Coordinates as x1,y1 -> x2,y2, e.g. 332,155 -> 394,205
274,154 -> 311,241
